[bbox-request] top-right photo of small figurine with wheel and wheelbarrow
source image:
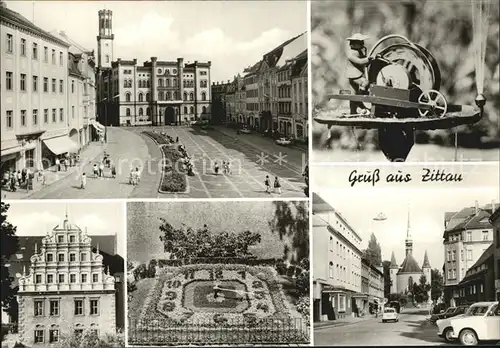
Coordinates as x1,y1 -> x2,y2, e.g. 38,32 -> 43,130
310,0 -> 500,162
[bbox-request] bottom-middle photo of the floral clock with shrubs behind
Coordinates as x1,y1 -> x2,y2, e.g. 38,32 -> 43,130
127,201 -> 310,346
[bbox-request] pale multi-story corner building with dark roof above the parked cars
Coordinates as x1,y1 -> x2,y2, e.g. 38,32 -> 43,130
443,202 -> 495,306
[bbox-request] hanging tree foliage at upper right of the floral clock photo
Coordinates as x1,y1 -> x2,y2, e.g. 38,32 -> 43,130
269,201 -> 309,263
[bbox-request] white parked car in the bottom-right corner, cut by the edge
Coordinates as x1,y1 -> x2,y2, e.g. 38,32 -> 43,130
451,301 -> 500,346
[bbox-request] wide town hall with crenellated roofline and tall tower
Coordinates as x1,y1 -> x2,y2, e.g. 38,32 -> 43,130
97,10 -> 212,126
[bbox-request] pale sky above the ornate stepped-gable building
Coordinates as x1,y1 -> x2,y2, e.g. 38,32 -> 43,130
7,201 -> 126,257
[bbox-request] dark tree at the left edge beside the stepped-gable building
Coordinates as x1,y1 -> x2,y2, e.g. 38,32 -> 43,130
0,202 -> 19,320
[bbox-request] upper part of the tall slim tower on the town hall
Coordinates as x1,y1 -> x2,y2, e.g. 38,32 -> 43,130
97,10 -> 115,69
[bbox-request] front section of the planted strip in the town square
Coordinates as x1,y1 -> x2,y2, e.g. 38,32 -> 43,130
160,146 -> 187,192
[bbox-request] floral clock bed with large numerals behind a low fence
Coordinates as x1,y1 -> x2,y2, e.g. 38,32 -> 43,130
130,264 -> 308,344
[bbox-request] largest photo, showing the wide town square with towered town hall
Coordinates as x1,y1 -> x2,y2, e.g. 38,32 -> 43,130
0,1 -> 309,199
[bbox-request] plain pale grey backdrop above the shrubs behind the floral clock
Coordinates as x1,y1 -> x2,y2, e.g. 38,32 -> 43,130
127,201 -> 304,262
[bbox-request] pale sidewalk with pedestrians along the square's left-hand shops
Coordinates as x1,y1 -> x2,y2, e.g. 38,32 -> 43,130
1,142 -> 107,200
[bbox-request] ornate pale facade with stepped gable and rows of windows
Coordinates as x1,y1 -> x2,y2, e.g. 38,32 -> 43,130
17,216 -> 116,347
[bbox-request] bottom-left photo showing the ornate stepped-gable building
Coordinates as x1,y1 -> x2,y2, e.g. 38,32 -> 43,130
0,202 -> 126,348
